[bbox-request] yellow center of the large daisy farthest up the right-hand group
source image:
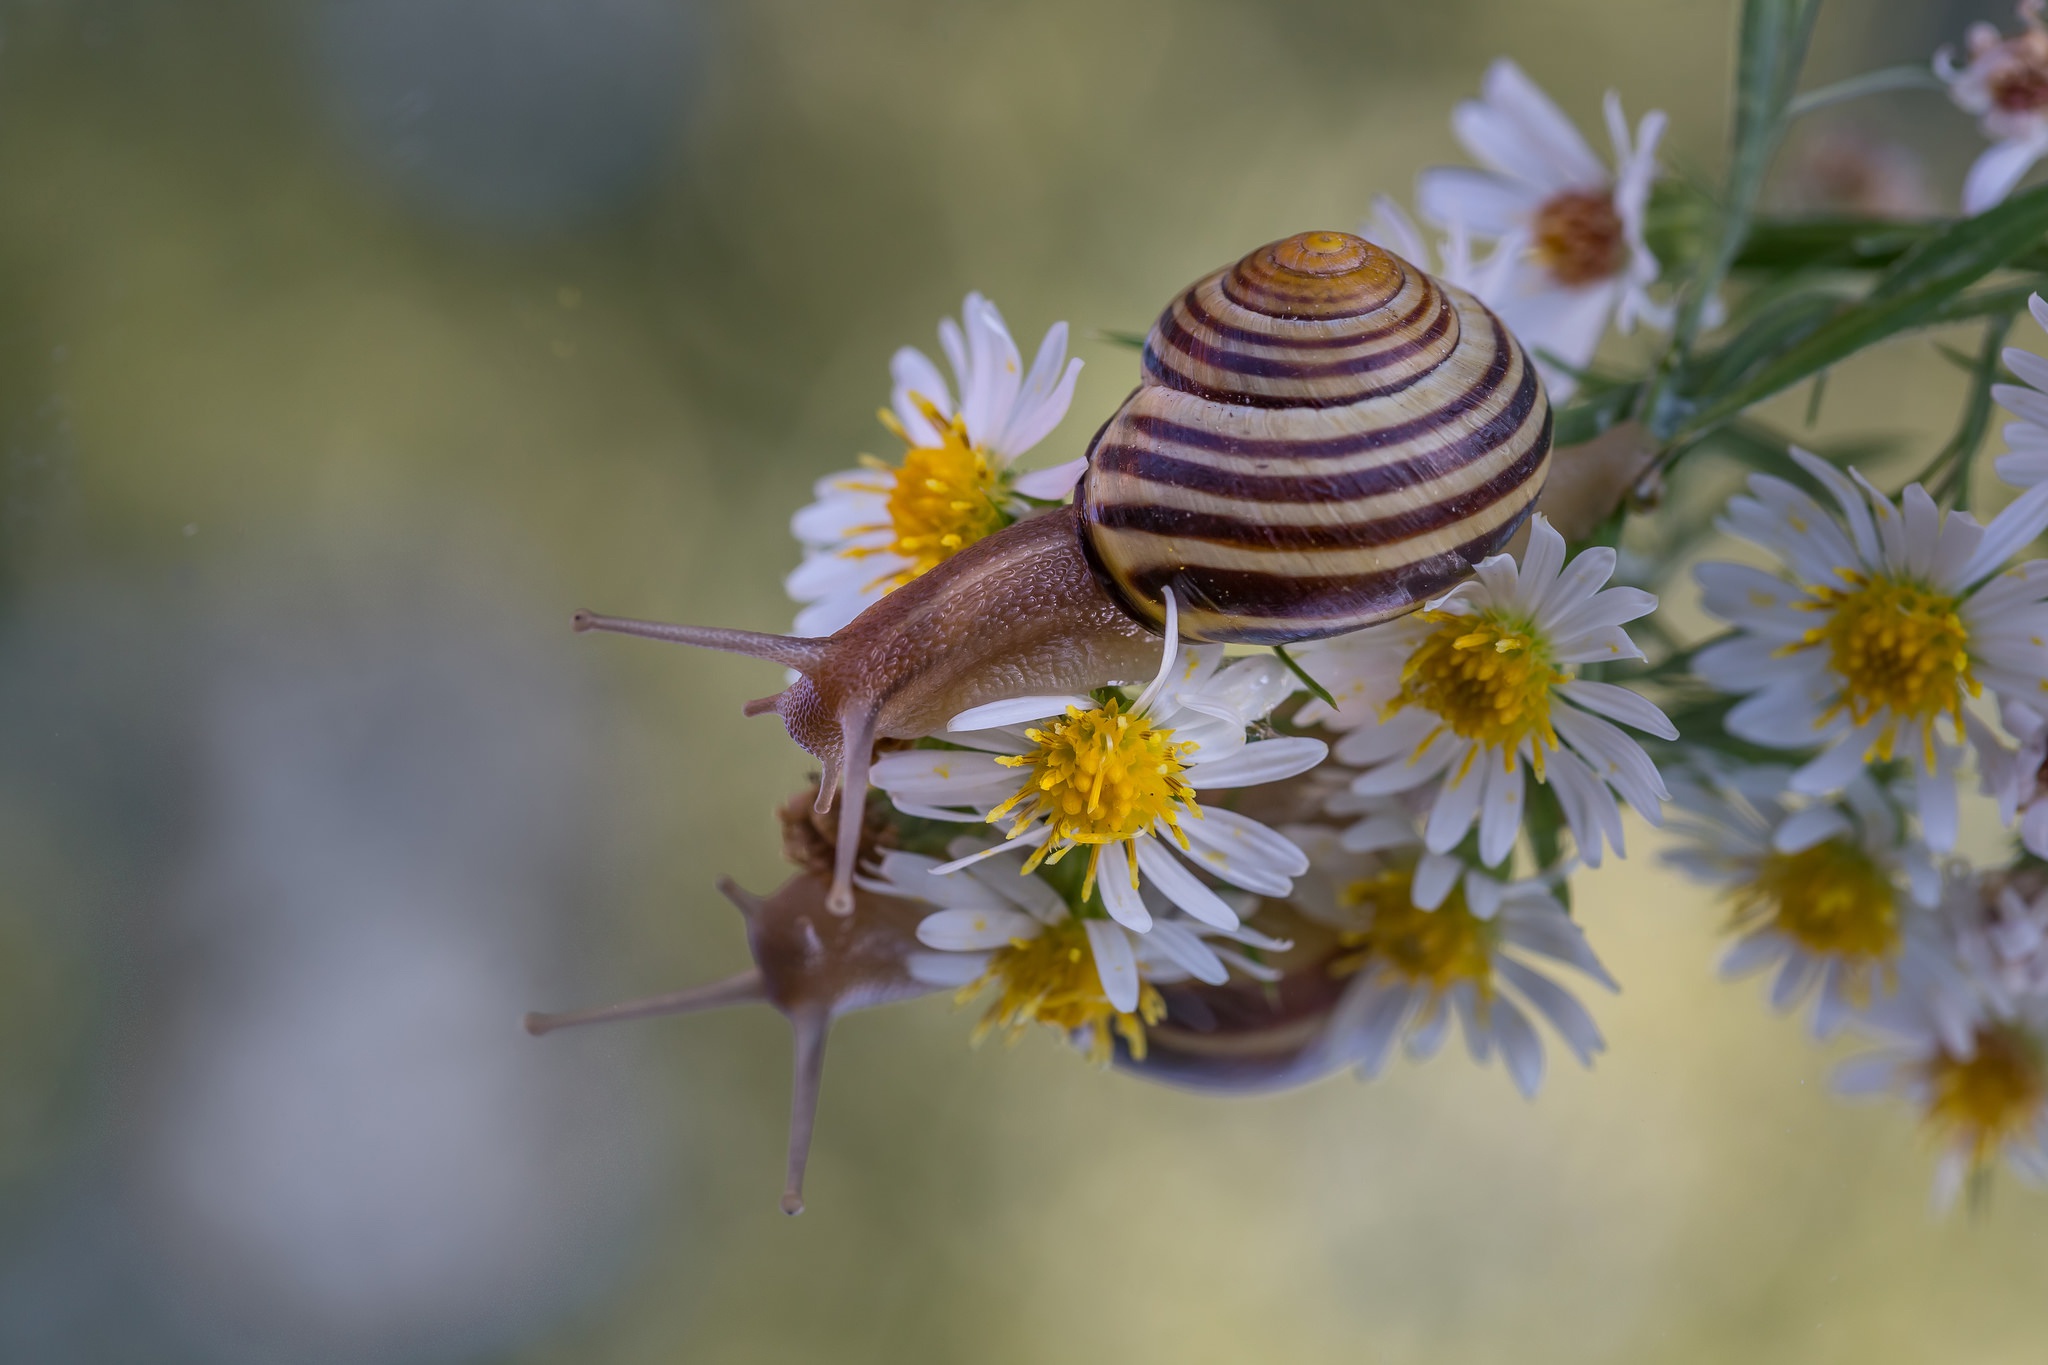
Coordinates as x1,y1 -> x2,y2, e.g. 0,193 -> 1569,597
1788,571 -> 1982,763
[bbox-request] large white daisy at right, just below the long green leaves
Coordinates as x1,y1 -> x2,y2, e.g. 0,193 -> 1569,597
1692,448 -> 2048,851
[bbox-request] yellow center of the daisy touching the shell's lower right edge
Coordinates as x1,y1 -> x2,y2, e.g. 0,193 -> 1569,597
1386,612 -> 1571,780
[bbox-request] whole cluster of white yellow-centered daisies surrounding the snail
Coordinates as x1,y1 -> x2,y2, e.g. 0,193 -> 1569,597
749,37 -> 2048,1197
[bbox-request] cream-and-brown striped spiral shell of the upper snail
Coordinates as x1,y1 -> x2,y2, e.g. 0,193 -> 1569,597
1077,231 -> 1550,645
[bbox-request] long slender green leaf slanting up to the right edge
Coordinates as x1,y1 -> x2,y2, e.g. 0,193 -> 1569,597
1677,186 -> 2048,436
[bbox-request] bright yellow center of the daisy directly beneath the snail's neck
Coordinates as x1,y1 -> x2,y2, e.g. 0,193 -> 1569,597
989,698 -> 1202,898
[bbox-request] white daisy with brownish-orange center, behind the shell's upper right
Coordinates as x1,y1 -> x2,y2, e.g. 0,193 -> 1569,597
1417,57 -> 1669,399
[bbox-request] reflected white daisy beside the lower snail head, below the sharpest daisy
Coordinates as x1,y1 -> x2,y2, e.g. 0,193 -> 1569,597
860,839 -> 1288,1062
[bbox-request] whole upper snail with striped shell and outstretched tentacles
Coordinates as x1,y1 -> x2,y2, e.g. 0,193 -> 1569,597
575,231 -> 1550,915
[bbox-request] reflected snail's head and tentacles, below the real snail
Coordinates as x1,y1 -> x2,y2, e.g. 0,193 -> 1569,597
526,796 -> 938,1214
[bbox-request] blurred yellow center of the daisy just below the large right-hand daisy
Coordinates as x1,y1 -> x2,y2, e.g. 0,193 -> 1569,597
1733,839 -> 1898,968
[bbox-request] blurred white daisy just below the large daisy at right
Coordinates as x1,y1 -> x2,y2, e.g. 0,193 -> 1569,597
1663,767 -> 1974,1040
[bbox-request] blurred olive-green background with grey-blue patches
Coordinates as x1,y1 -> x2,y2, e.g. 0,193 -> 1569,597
0,0 -> 2048,1363
